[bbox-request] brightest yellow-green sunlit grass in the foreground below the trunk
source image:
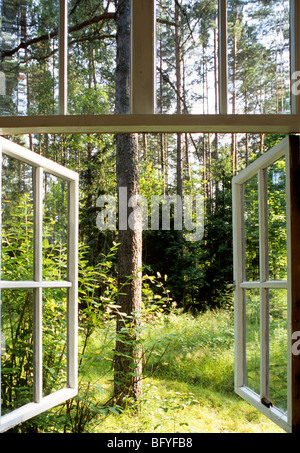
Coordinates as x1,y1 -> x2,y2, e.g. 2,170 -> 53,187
97,380 -> 283,433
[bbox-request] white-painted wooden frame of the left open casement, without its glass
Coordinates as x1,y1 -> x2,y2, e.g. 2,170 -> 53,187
0,137 -> 78,432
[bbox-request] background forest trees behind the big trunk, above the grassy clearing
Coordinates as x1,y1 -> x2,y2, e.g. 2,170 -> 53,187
1,0 -> 289,310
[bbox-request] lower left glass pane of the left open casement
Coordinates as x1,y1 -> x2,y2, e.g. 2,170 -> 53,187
1,290 -> 33,415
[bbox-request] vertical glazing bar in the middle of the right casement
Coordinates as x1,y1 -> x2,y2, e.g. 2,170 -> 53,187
258,169 -> 269,398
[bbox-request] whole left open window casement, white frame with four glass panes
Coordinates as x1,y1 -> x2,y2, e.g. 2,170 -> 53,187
0,137 -> 78,432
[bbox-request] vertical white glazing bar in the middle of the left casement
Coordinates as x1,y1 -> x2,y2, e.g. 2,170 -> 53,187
33,167 -> 43,403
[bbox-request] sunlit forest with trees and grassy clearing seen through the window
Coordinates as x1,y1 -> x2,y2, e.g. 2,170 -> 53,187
0,0 -> 290,433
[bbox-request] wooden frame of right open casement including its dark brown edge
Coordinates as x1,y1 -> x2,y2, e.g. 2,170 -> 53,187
232,136 -> 300,432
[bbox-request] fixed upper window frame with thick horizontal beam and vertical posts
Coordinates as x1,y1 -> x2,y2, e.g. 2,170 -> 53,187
0,0 -> 300,135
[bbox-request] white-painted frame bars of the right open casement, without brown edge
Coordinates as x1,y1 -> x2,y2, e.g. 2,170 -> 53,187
232,137 -> 292,432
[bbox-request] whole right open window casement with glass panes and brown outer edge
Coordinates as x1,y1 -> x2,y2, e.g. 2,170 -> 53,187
232,136 -> 300,432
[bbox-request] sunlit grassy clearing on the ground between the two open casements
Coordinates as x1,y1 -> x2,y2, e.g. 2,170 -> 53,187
78,310 -> 283,433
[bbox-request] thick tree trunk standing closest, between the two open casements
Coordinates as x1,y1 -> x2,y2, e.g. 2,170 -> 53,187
114,0 -> 142,406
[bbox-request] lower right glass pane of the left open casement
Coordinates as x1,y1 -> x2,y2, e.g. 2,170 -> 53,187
43,288 -> 67,396
